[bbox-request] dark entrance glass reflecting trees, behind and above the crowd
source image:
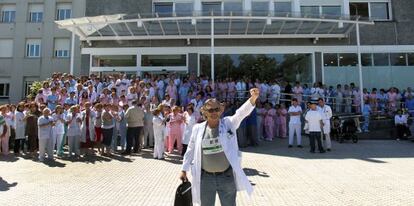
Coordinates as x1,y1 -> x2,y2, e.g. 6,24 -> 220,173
200,54 -> 312,82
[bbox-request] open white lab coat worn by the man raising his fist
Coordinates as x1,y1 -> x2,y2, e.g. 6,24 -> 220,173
182,100 -> 254,205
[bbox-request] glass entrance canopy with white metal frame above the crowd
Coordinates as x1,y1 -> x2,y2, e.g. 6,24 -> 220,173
56,11 -> 374,41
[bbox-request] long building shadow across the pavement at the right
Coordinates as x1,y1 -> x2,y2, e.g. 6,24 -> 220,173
242,137 -> 414,163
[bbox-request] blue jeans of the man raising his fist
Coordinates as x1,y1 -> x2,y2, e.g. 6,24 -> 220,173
200,168 -> 237,206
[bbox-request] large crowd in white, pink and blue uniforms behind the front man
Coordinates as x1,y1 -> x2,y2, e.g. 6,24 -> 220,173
0,73 -> 414,161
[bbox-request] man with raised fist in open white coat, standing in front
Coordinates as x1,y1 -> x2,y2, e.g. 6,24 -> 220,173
180,88 -> 260,206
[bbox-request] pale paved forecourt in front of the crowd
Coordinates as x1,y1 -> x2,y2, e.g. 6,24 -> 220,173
0,139 -> 414,206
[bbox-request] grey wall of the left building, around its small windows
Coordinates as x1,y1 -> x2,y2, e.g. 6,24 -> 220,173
0,0 -> 85,103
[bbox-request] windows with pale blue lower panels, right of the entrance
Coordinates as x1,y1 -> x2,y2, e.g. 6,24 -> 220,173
323,53 -> 414,89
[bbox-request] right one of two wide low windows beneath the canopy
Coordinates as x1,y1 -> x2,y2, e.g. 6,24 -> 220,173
141,54 -> 187,67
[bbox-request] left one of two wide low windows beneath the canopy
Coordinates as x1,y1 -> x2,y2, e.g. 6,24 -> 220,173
92,55 -> 137,67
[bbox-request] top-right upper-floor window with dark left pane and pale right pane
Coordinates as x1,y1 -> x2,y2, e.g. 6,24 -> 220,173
349,2 -> 391,20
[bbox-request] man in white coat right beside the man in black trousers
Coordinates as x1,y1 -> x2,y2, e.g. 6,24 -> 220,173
318,98 -> 332,152
